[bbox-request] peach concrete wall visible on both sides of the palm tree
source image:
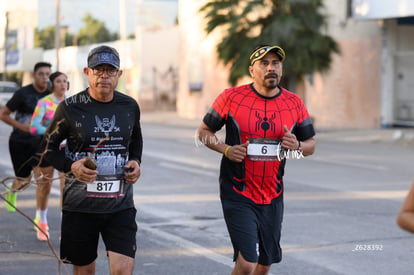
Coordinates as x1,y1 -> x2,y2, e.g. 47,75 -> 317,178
177,0 -> 381,128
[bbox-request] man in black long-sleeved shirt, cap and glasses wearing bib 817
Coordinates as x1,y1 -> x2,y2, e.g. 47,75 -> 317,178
46,46 -> 142,274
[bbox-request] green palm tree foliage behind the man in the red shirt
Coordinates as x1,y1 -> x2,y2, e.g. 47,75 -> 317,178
200,0 -> 340,85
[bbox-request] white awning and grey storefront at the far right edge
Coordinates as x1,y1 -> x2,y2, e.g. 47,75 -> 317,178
352,0 -> 414,127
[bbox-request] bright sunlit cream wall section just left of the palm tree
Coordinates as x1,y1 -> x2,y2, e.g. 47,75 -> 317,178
177,0 -> 229,119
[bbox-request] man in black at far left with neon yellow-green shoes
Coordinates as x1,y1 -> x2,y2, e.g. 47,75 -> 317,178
0,62 -> 51,212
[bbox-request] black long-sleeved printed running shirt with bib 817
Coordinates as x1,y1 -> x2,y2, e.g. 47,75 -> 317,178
47,90 -> 142,213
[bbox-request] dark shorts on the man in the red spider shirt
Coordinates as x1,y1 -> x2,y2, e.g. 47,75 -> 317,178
221,196 -> 283,265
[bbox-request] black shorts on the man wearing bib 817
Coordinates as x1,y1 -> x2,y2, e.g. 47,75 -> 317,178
60,208 -> 138,266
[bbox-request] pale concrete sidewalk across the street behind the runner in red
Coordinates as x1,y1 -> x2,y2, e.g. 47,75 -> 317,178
141,111 -> 414,146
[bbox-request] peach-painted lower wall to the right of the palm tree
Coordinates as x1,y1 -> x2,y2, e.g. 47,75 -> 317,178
305,38 -> 380,129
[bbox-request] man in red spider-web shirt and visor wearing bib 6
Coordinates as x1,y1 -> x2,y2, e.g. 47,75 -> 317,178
198,46 -> 315,274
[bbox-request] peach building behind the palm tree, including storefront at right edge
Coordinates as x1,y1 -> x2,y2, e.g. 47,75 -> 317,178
177,0 -> 414,129
